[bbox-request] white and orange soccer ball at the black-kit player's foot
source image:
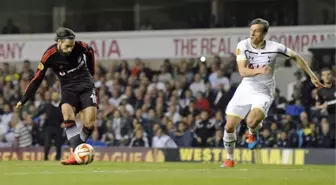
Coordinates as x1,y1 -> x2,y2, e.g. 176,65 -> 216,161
74,143 -> 95,164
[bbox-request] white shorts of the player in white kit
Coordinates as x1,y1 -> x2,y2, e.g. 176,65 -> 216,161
225,86 -> 273,119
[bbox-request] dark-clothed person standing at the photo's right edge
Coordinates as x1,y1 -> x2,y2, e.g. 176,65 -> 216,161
316,68 -> 336,147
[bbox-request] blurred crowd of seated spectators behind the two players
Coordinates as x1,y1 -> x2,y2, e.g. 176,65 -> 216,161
0,56 -> 335,148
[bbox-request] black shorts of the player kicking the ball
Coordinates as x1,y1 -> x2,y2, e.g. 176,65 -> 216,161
61,88 -> 99,114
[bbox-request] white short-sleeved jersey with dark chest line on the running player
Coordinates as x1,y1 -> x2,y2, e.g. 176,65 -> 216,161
236,39 -> 293,96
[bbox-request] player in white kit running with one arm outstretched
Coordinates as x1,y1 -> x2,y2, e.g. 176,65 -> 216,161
222,18 -> 323,167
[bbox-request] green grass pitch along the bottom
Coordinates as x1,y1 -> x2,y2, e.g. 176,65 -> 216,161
0,161 -> 336,185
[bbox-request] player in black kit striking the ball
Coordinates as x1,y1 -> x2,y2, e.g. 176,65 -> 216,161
16,28 -> 98,165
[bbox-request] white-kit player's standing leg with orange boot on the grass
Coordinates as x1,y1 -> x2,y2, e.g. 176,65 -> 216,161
221,115 -> 242,167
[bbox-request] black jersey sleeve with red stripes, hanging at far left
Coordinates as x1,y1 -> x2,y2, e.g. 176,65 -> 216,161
21,47 -> 56,104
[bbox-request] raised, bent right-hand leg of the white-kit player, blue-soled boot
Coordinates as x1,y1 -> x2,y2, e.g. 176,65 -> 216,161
246,108 -> 265,150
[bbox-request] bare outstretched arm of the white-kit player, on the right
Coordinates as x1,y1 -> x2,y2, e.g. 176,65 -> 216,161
290,51 -> 325,88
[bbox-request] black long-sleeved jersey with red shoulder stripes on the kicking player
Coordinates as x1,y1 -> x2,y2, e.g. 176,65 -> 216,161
21,41 -> 95,104
